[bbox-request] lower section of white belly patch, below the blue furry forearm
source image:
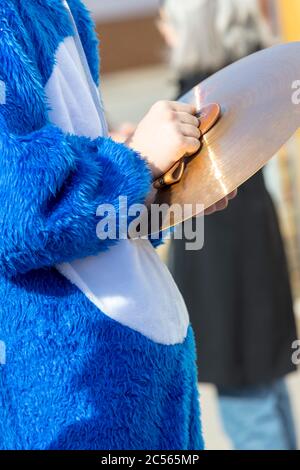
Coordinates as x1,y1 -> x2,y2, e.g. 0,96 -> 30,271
59,240 -> 189,345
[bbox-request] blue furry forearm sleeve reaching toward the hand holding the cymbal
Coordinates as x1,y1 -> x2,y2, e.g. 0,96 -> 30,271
0,121 -> 150,275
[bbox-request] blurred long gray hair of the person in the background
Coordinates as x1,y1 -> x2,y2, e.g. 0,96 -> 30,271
164,0 -> 274,74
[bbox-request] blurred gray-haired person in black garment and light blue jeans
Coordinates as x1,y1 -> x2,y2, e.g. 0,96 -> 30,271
159,0 -> 297,450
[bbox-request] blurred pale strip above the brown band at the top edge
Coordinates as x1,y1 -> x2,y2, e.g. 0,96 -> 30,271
84,0 -> 159,21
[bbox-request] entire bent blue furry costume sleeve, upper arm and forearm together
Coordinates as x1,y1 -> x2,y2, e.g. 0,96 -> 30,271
0,16 -> 151,276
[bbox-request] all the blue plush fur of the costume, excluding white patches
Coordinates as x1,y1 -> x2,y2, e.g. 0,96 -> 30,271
0,0 -> 203,449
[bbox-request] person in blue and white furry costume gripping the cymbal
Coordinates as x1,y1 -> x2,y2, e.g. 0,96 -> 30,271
0,0 -> 233,450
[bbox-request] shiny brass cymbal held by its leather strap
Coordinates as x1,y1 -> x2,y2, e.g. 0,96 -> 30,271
144,42 -> 300,233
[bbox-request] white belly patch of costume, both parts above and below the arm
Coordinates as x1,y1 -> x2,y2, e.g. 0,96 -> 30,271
46,37 -> 189,345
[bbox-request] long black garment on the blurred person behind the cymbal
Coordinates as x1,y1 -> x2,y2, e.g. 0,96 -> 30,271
169,72 -> 297,387
